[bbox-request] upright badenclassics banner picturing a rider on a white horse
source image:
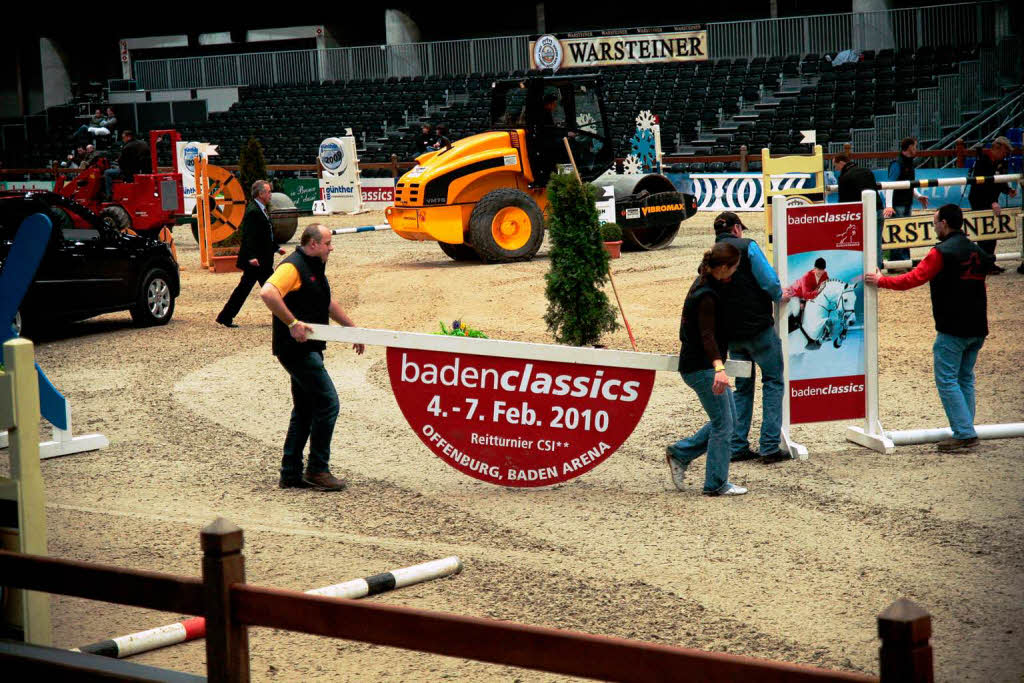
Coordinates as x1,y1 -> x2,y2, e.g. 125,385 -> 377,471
782,202 -> 864,424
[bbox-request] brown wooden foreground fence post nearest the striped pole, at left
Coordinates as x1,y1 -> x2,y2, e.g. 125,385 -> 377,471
200,517 -> 249,683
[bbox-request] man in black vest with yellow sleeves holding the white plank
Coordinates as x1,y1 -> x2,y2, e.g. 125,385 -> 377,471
260,223 -> 364,490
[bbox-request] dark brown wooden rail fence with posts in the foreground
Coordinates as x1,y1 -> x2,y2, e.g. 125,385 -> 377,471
0,518 -> 934,683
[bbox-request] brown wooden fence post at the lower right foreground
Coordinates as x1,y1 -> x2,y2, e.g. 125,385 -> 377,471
879,598 -> 935,683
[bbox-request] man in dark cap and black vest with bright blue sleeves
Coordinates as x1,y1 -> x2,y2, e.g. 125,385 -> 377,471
715,211 -> 790,464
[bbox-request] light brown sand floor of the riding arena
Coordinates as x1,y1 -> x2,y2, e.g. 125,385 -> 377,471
8,214 -> 1024,681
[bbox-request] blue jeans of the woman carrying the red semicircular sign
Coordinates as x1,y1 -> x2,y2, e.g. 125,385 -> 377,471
669,370 -> 736,493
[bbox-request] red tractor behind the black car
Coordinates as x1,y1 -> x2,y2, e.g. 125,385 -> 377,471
53,130 -> 184,239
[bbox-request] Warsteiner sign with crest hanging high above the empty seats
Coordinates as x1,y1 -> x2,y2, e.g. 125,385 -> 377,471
529,25 -> 708,70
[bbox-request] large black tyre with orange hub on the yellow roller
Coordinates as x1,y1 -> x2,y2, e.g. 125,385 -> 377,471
469,187 -> 544,263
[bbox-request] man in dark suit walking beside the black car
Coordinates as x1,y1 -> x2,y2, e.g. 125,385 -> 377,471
217,180 -> 285,328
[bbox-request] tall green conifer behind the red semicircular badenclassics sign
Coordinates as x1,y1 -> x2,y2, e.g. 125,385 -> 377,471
544,175 -> 618,346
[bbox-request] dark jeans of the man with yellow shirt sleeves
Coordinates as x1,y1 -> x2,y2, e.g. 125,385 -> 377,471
278,351 -> 338,480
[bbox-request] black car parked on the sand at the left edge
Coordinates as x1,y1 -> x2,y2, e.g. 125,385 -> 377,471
0,191 -> 180,327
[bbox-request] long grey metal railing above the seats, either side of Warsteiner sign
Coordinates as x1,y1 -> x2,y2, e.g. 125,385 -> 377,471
133,0 -> 1007,90
